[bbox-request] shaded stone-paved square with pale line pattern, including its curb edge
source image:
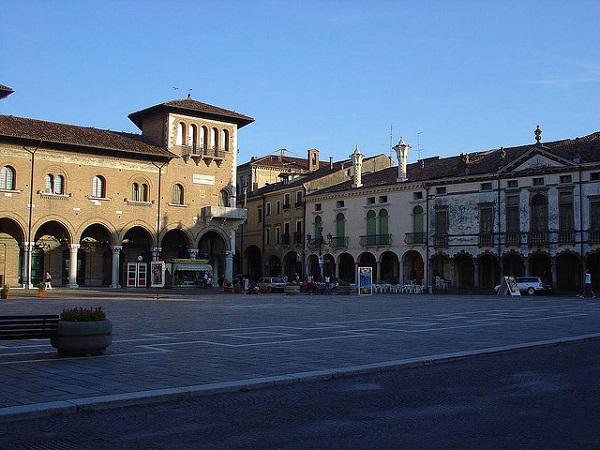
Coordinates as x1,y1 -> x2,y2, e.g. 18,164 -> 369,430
0,289 -> 600,421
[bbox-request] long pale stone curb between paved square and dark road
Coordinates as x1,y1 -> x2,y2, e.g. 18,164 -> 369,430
0,333 -> 600,423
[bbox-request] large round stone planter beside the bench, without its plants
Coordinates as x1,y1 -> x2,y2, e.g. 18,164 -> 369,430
50,320 -> 112,356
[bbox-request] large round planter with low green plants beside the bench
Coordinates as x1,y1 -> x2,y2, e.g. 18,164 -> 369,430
51,307 -> 112,356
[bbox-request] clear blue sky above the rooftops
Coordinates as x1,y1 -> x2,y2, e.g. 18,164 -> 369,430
0,0 -> 600,163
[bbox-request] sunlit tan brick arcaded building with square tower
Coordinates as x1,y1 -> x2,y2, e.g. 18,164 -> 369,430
0,90 -> 254,287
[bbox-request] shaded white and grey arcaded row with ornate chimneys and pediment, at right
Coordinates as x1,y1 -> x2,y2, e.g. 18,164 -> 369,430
305,128 -> 600,292
